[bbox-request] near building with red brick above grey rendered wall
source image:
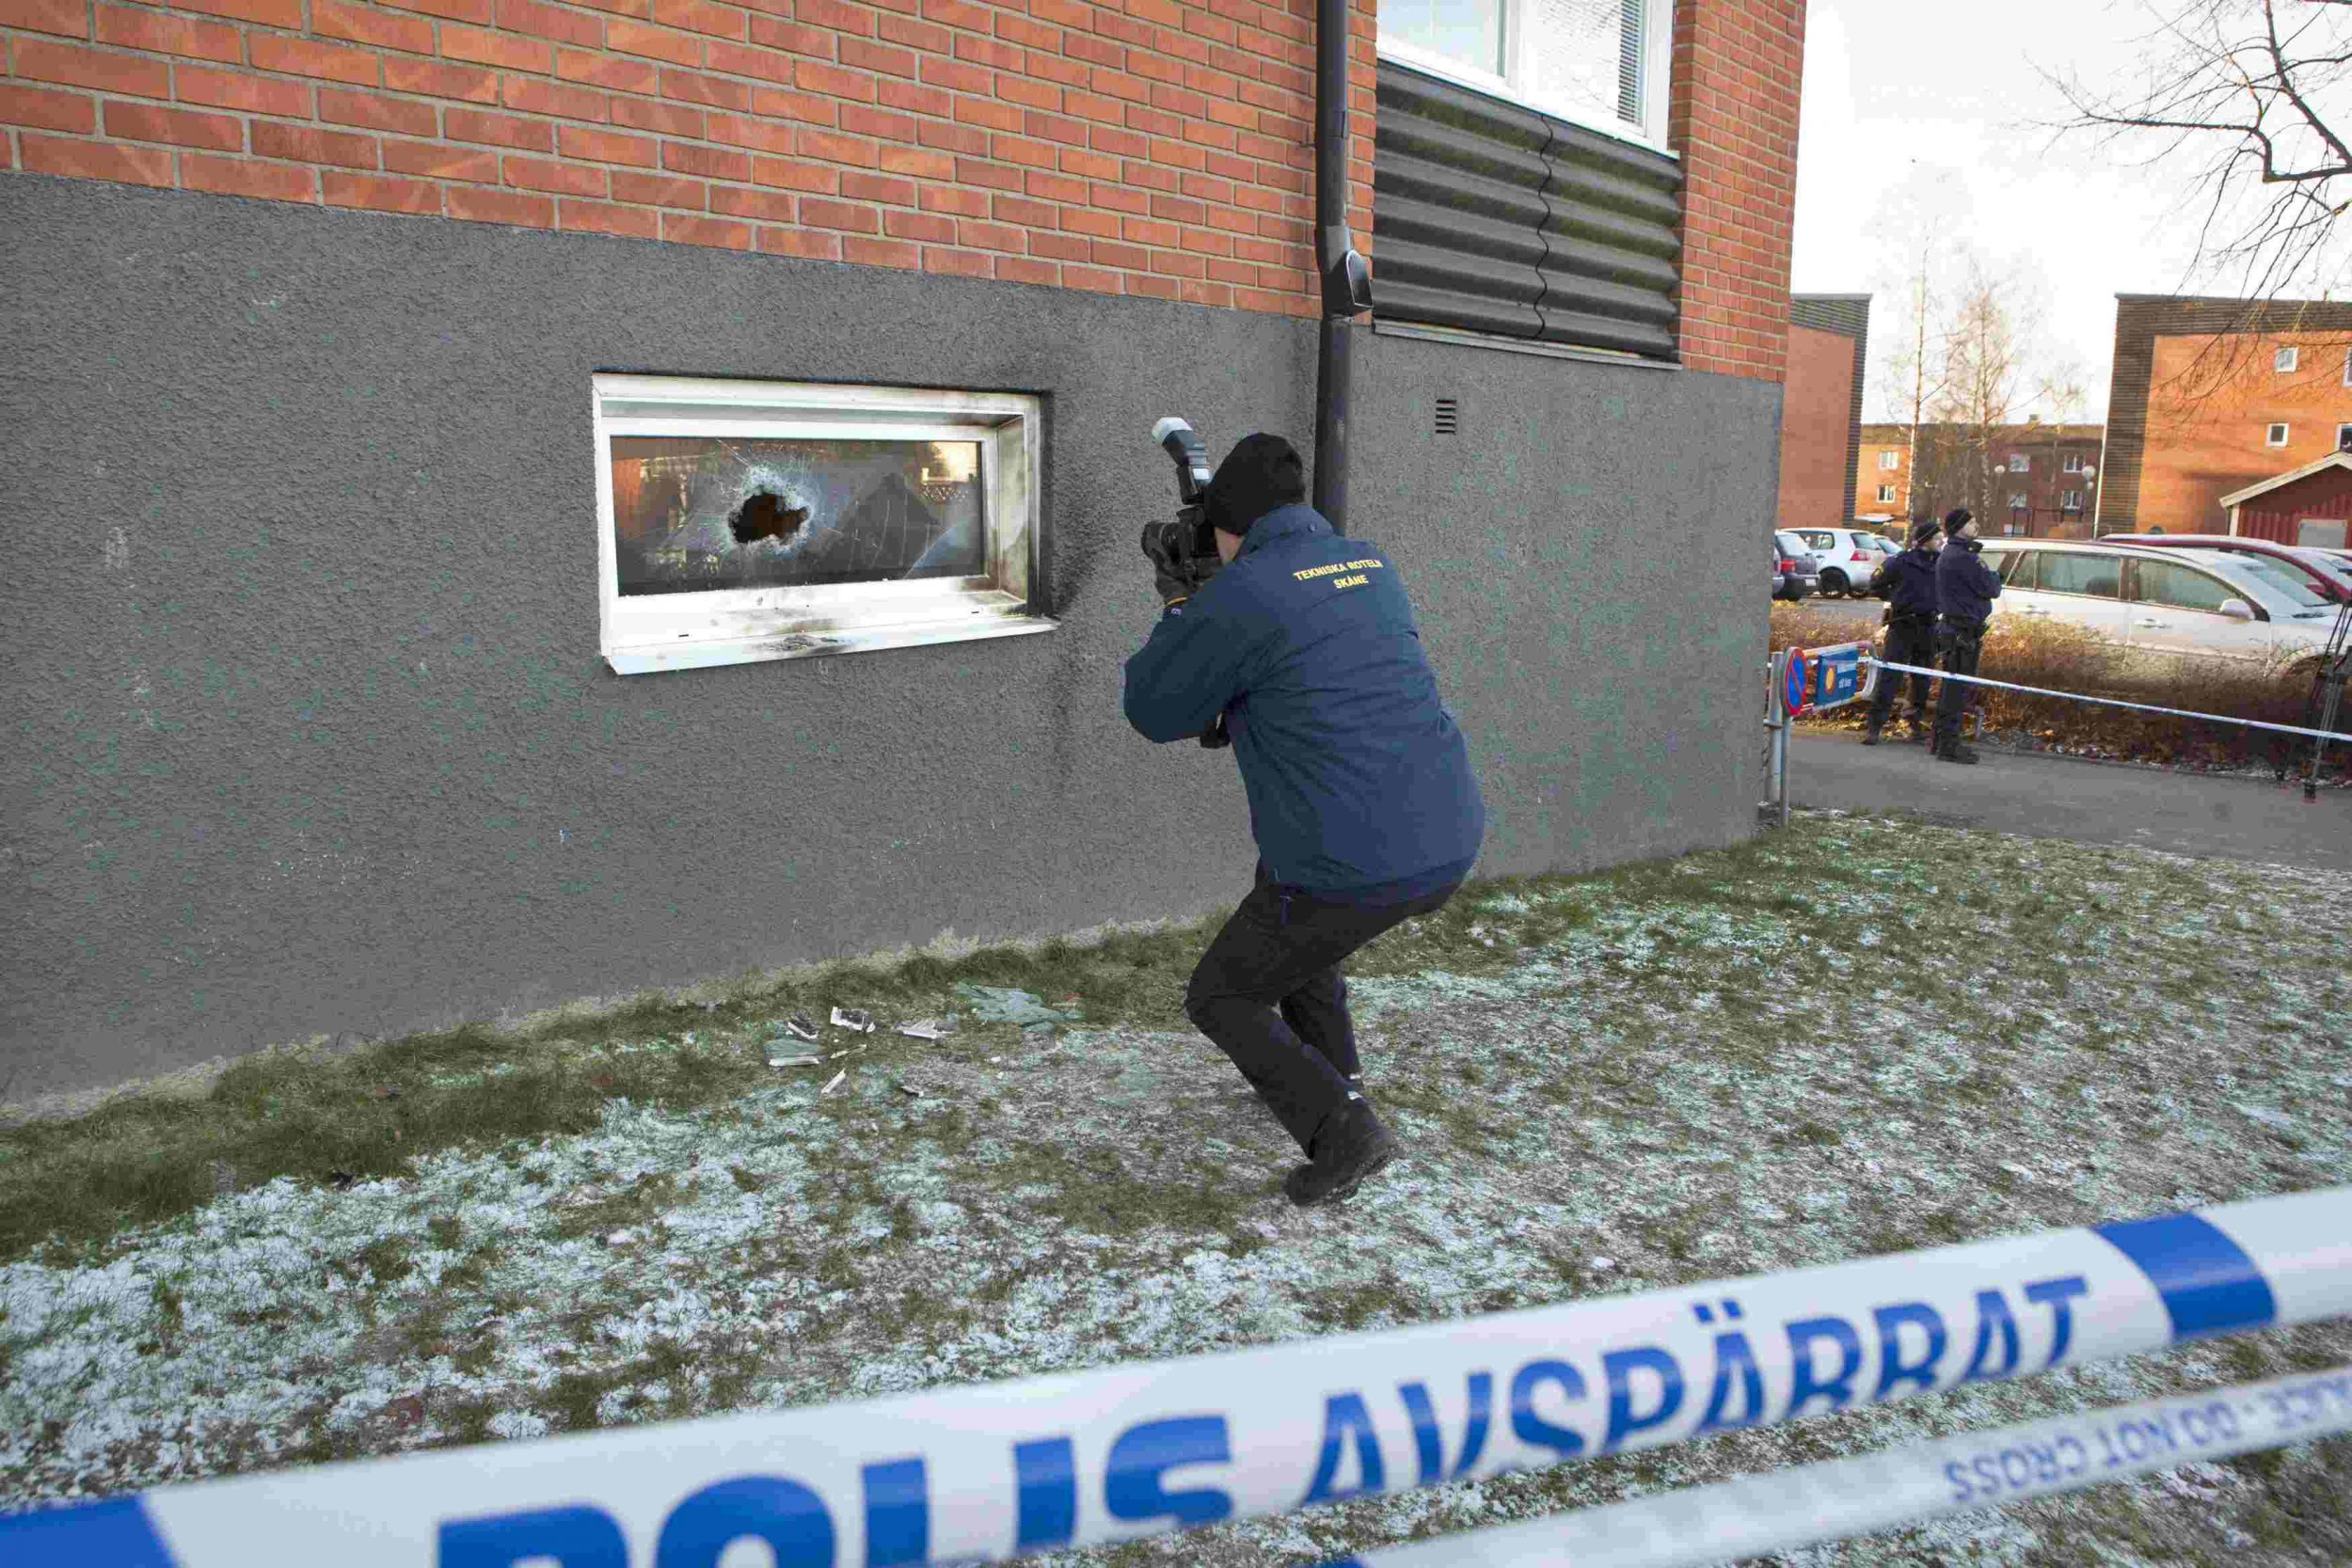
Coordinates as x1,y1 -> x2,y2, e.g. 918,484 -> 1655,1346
0,0 -> 1804,1093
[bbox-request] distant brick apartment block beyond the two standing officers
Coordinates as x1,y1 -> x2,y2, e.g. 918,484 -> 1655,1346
1853,419 -> 2106,538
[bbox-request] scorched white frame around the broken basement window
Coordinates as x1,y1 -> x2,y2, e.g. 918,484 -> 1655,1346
591,376 -> 1058,674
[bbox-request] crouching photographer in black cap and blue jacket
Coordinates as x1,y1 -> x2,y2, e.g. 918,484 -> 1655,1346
1127,435 -> 1486,1206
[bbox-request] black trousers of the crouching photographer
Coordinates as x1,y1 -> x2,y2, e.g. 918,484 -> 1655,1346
1184,865 -> 1461,1152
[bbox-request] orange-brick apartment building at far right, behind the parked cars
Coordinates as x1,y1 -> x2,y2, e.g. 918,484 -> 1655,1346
2098,293 -> 2352,533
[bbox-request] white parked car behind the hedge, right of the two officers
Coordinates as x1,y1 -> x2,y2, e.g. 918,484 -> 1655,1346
1985,538 -> 2336,663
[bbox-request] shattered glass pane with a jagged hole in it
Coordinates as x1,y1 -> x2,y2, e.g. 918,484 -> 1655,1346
612,435 -> 988,597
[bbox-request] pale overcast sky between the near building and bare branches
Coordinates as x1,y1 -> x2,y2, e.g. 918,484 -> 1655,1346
1795,0 -> 2230,420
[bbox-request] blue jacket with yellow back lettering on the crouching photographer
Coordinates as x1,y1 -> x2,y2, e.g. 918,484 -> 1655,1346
1127,505 -> 1486,903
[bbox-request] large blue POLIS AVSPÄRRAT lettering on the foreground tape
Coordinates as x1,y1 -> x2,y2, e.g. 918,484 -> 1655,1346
436,1275 -> 2089,1568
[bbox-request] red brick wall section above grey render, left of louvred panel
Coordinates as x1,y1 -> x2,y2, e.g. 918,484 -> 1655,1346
0,0 -> 1374,315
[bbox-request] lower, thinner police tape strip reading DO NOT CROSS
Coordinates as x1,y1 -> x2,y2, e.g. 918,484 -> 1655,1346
1325,1366 -> 2352,1568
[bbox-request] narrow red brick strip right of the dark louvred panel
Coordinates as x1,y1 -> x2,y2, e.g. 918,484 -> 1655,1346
1668,0 -> 1804,381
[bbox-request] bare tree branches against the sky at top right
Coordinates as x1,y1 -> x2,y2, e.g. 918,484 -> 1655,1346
2044,0 -> 2352,305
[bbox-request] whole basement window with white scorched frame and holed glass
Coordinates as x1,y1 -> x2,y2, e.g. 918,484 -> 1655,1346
596,376 -> 1054,674
